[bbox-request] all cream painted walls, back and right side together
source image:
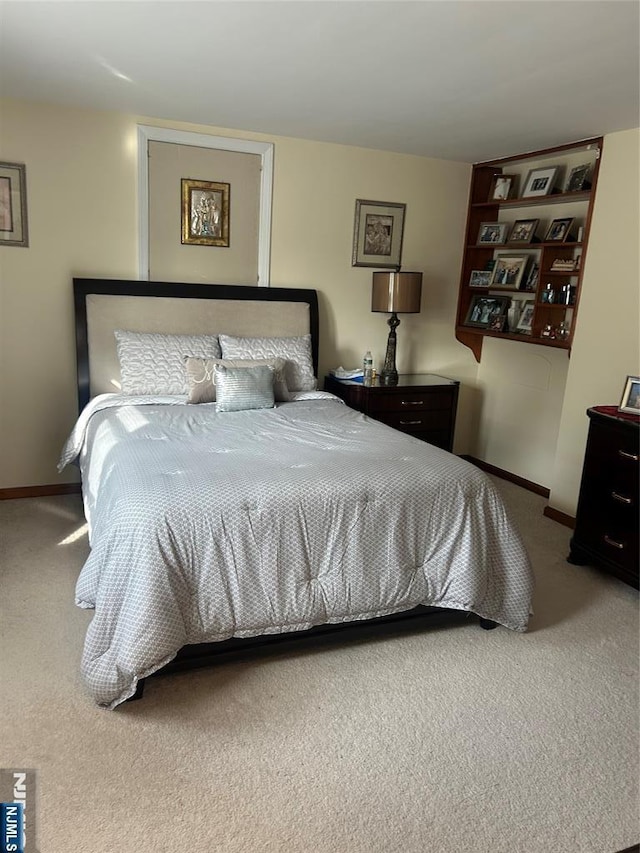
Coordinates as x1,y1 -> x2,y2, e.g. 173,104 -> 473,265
0,97 -> 639,514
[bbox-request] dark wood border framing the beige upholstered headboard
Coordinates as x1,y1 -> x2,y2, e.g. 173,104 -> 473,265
73,278 -> 318,410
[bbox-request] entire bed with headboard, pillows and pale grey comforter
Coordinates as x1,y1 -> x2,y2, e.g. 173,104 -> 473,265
59,279 -> 533,709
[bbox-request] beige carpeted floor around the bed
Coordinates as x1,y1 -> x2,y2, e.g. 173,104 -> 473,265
0,480 -> 640,853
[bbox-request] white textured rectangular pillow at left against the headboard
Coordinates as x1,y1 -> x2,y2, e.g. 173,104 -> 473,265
114,329 -> 220,394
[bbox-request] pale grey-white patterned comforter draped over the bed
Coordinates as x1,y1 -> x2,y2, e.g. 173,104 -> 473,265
60,395 -> 532,708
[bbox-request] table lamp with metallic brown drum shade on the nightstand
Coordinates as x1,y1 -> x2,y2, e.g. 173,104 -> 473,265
371,270 -> 422,385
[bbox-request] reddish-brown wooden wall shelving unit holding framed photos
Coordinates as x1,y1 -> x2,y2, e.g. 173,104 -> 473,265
456,137 -> 603,361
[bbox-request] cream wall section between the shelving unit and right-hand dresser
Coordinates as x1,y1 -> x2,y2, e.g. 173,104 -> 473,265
548,129 -> 640,515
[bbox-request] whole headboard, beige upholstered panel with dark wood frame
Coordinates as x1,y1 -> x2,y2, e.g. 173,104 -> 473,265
73,279 -> 318,408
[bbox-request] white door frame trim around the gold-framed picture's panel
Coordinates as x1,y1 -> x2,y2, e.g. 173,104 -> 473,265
138,124 -> 273,287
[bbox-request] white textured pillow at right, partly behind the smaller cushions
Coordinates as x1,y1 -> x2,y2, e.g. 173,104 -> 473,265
219,335 -> 318,391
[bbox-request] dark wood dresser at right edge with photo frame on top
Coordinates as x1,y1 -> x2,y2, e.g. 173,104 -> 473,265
567,406 -> 640,588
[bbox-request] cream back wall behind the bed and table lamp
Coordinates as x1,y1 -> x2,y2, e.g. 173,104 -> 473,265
0,101 -> 475,488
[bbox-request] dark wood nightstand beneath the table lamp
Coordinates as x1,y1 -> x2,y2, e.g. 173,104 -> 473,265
324,373 -> 460,451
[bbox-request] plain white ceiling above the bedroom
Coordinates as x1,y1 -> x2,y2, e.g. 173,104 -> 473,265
0,0 -> 640,162
